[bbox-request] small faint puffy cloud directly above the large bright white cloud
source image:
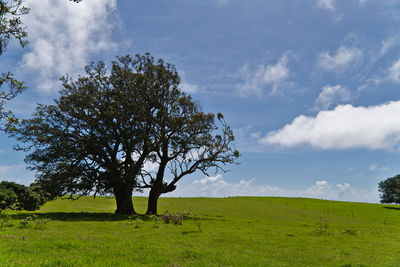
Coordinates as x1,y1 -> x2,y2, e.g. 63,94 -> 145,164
315,85 -> 352,109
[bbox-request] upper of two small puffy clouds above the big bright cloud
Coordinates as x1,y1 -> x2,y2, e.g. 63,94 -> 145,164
317,46 -> 363,72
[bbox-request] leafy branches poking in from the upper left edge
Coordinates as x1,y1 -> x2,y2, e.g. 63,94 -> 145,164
0,0 -> 29,129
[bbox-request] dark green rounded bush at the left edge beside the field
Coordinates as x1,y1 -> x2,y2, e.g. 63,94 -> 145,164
0,181 -> 44,211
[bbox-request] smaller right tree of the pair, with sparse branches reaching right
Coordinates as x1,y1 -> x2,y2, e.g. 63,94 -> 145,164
141,100 -> 239,214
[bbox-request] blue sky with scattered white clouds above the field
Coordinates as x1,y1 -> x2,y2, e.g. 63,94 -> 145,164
0,0 -> 400,202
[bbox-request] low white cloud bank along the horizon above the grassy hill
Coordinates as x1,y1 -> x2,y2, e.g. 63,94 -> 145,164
169,175 -> 379,202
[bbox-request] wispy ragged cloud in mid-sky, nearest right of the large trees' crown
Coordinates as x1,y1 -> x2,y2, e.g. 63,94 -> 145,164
239,53 -> 290,96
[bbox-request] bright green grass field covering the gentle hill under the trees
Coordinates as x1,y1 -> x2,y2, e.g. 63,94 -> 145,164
0,197 -> 400,266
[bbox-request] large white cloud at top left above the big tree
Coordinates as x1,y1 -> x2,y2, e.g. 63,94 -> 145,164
21,0 -> 117,91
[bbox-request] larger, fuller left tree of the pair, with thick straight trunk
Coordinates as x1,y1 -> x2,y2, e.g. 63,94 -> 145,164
12,55 -> 173,214
